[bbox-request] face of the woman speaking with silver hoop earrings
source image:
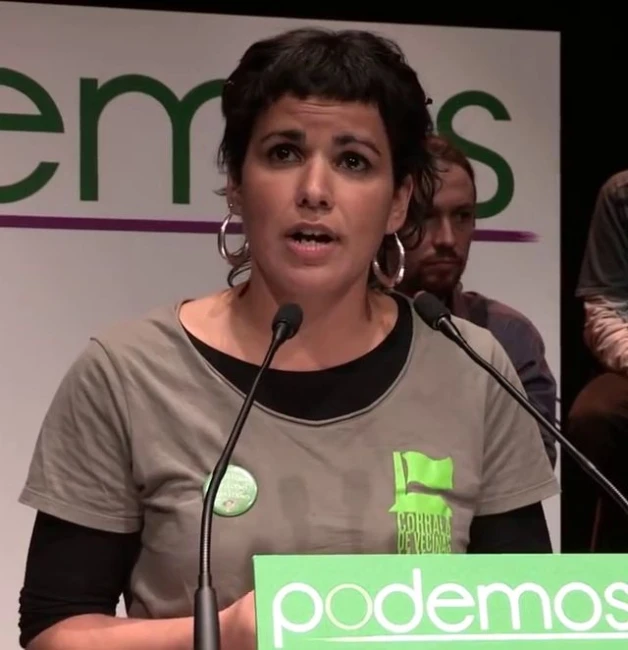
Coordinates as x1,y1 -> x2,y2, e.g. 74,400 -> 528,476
228,96 -> 412,293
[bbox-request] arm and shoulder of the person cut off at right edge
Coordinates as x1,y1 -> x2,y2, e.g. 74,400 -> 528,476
576,171 -> 628,376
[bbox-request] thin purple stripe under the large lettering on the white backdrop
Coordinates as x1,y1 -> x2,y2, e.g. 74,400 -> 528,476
0,214 -> 539,243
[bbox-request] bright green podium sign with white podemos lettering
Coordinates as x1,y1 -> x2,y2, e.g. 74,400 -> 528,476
253,555 -> 628,650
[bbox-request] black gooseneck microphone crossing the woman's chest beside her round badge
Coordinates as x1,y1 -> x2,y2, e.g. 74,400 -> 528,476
194,303 -> 303,650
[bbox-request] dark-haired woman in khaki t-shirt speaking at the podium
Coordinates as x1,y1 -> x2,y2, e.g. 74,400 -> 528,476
20,24 -> 557,650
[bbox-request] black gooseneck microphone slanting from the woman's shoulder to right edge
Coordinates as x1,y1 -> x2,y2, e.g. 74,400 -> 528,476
413,291 -> 628,515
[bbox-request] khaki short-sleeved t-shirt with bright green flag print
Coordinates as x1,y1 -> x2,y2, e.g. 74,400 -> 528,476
20,296 -> 558,618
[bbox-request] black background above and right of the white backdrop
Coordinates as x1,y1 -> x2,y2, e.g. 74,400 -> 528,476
17,0 -> 628,552
